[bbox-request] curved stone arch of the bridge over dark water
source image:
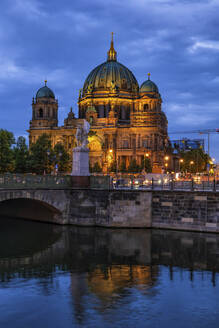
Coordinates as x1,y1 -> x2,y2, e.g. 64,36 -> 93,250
0,190 -> 67,224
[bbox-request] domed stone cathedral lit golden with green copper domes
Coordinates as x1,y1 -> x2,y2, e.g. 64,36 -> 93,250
28,34 -> 170,173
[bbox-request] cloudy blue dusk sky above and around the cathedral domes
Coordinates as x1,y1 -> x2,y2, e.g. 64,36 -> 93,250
0,0 -> 219,161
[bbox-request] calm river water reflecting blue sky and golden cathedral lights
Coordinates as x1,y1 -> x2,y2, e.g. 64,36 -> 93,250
0,218 -> 219,327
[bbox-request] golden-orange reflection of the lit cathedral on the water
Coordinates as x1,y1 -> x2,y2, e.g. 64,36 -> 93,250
70,264 -> 158,322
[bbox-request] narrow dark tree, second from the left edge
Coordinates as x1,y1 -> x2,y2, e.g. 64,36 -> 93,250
14,137 -> 29,173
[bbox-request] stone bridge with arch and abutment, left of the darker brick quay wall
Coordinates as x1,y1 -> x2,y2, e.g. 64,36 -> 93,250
0,189 -> 151,228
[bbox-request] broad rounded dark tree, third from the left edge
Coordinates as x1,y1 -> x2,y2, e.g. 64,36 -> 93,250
30,133 -> 54,174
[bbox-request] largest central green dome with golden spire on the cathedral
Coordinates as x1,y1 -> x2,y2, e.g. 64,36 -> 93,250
83,35 -> 139,96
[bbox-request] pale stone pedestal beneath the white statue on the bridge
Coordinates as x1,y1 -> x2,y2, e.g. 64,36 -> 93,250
71,147 -> 90,176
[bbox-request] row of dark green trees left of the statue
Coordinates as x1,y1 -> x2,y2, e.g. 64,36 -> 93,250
0,129 -> 71,174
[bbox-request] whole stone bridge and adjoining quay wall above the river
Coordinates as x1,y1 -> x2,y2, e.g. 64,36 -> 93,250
0,177 -> 219,233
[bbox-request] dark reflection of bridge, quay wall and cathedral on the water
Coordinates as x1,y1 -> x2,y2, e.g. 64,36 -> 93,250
0,219 -> 219,323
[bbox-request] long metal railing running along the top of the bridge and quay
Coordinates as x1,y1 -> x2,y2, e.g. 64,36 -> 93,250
0,174 -> 219,191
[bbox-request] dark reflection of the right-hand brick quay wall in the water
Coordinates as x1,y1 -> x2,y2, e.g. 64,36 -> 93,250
151,230 -> 219,284
